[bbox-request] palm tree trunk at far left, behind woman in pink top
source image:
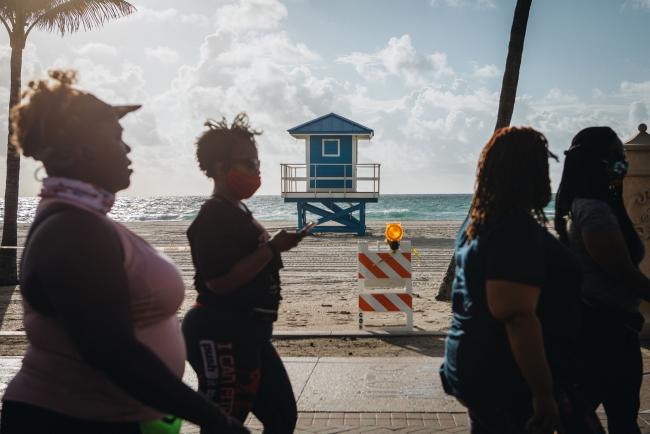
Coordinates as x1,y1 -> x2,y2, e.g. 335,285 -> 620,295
0,38 -> 25,285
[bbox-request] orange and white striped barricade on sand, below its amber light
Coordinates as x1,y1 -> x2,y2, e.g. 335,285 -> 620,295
357,241 -> 413,331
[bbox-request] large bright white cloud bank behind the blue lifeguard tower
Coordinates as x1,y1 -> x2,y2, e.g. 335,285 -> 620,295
153,11 -> 498,194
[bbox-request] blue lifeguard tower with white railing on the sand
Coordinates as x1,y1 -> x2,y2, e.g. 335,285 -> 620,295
281,113 -> 380,235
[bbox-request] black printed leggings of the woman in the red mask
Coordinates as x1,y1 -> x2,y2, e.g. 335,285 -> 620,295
183,306 -> 297,434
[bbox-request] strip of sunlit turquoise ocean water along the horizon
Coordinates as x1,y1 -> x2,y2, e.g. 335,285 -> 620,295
0,194 -> 554,223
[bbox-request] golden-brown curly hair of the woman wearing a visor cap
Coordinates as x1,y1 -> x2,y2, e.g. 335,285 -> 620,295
10,70 -> 111,168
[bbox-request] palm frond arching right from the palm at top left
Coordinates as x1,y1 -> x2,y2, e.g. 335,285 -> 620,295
26,0 -> 136,35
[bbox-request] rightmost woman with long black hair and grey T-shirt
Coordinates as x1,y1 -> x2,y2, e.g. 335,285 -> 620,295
555,127 -> 650,434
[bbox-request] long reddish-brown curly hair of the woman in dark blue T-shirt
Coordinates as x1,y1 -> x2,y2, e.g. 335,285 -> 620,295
467,127 -> 552,239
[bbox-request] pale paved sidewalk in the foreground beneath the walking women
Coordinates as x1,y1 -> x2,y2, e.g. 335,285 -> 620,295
0,357 -> 650,434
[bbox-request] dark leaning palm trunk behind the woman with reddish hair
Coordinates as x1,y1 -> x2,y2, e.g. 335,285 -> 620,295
436,0 -> 533,300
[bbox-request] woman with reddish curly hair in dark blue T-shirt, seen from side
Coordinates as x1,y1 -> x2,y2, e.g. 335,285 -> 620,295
440,127 -> 603,434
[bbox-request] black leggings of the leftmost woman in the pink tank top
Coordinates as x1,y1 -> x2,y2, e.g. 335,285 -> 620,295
0,401 -> 141,434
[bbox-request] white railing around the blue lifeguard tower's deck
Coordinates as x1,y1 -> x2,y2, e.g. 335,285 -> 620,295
280,163 -> 381,197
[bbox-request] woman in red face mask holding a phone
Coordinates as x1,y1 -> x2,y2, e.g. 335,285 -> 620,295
183,113 -> 304,433
